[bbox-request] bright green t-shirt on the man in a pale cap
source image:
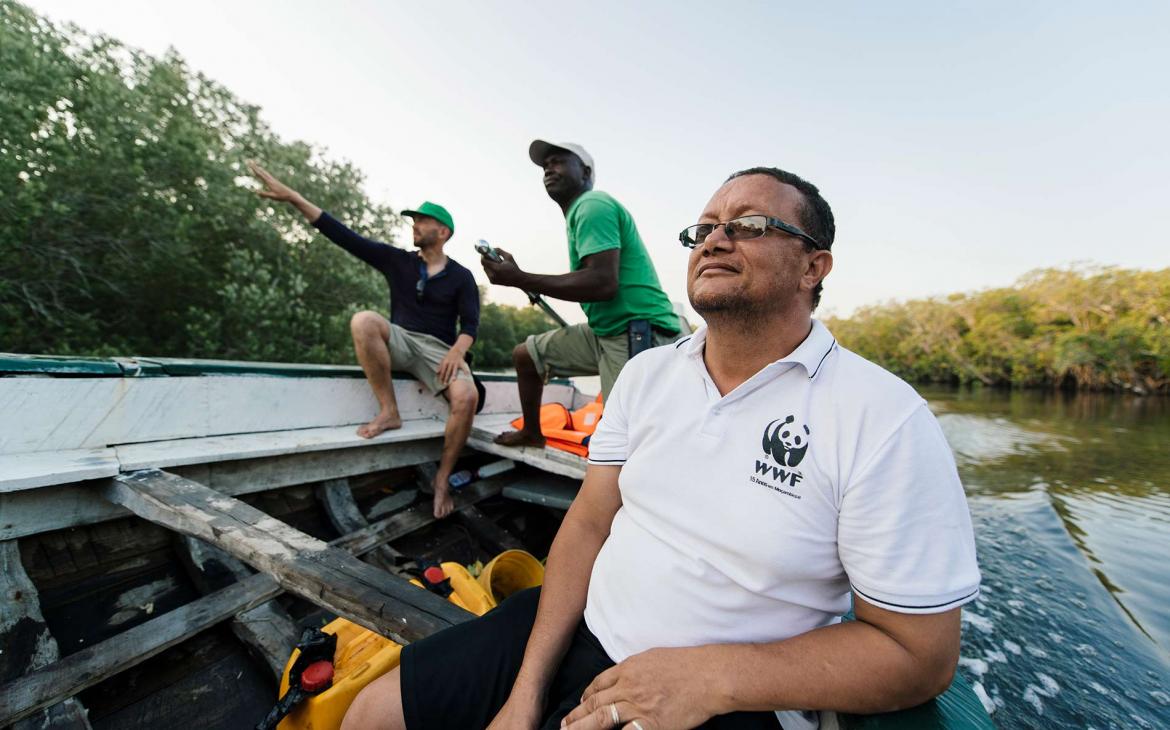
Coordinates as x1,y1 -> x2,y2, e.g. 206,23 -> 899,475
565,191 -> 679,337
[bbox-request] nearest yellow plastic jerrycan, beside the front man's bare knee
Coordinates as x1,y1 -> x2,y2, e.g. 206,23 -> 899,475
277,619 -> 402,730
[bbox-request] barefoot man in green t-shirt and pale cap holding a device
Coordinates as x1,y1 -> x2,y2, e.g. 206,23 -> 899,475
482,139 -> 680,446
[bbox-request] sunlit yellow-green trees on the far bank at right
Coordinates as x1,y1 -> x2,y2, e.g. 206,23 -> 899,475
826,268 -> 1170,393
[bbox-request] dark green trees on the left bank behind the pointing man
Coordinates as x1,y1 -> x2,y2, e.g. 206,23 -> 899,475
0,0 -> 551,367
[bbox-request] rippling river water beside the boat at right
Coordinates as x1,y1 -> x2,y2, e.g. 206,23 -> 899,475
923,390 -> 1170,729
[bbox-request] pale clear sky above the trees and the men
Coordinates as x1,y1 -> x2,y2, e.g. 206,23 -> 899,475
28,0 -> 1170,321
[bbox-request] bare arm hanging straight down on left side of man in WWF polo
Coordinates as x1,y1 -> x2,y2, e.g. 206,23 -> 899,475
491,464 -> 621,728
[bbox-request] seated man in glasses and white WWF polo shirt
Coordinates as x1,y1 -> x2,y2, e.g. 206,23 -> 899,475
345,167 -> 979,730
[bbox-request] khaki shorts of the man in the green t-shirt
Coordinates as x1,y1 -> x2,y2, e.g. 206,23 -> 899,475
524,324 -> 681,399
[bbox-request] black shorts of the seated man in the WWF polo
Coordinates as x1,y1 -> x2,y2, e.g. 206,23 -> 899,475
399,588 -> 780,730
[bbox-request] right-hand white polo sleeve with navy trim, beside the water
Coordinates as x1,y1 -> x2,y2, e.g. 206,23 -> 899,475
838,402 -> 979,613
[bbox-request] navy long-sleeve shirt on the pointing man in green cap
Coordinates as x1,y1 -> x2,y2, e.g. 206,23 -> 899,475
312,212 -> 480,345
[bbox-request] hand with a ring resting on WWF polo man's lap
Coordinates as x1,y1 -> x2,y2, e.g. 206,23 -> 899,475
564,647 -> 722,730
